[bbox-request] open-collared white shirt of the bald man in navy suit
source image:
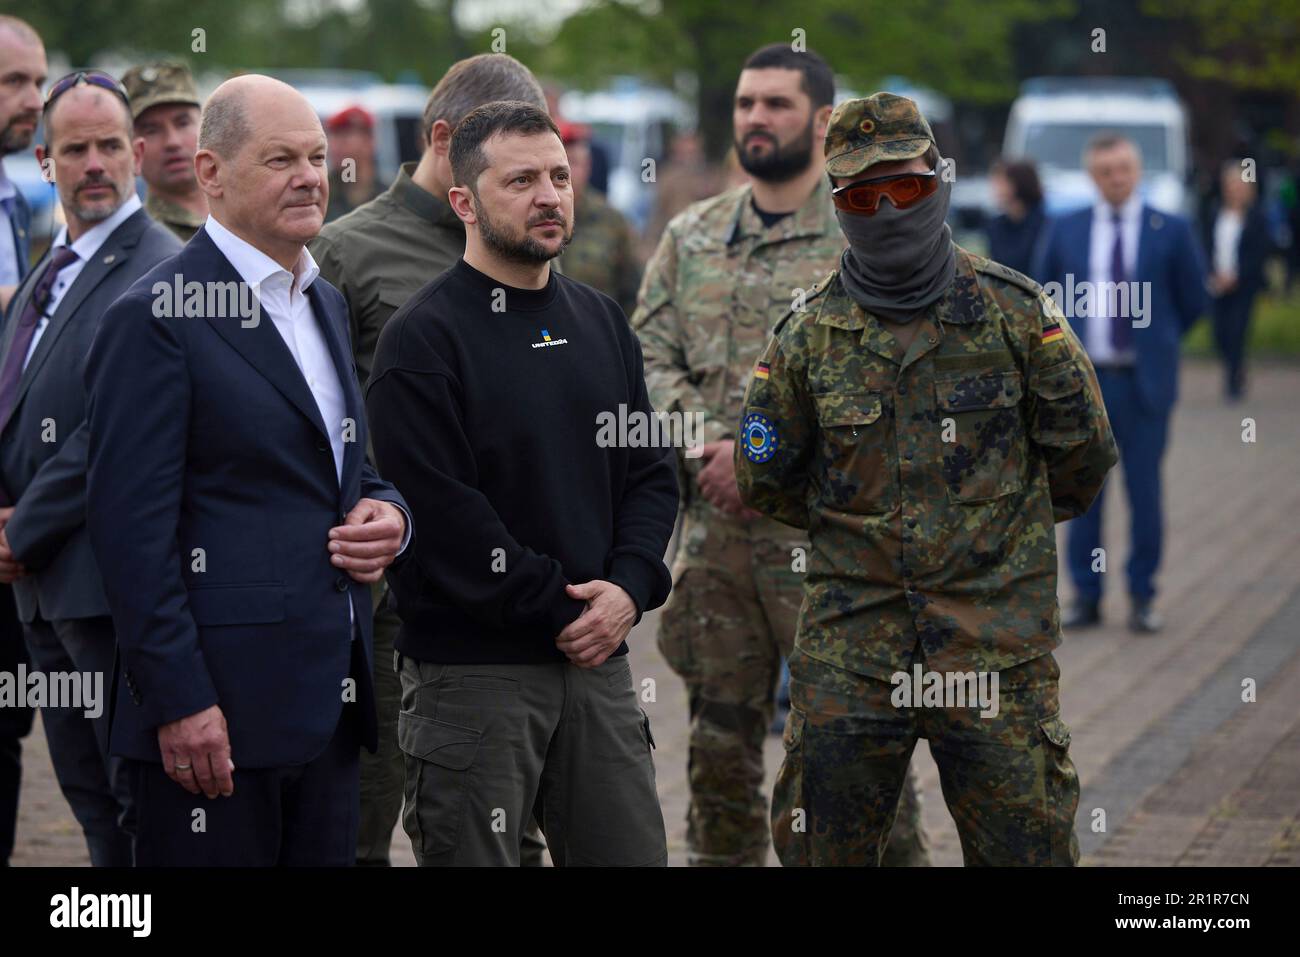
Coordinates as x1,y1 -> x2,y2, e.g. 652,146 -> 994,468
203,215 -> 411,638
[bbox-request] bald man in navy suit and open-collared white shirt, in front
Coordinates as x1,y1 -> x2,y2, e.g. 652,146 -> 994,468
86,75 -> 410,866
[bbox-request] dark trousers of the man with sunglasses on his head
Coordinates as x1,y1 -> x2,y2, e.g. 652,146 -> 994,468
26,616 -> 131,867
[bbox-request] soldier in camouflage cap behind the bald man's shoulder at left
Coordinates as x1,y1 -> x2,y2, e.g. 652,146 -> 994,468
122,62 -> 208,243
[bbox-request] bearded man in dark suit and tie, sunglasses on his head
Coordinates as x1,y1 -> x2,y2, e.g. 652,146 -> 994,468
0,74 -> 181,866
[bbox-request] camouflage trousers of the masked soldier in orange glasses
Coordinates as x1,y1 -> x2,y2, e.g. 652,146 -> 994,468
772,649 -> 1079,866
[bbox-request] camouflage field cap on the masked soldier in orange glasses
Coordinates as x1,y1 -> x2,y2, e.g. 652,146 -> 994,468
826,94 -> 935,176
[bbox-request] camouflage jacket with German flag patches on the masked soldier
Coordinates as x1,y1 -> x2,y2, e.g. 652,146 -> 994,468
736,248 -> 1118,681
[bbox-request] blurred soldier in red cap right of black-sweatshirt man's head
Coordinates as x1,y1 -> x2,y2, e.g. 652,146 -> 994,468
560,122 -> 641,316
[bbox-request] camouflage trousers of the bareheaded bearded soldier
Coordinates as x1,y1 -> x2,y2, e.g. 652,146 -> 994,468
659,503 -> 930,866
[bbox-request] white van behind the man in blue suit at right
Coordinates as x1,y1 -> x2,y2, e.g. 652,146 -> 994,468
1002,77 -> 1195,215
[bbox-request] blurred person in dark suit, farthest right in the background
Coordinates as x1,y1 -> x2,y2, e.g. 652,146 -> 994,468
1204,160 -> 1273,400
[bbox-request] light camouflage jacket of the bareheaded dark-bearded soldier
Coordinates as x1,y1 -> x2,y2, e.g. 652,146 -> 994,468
632,179 -> 845,502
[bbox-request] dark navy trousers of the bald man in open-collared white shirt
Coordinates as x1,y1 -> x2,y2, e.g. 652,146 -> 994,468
126,642 -> 371,867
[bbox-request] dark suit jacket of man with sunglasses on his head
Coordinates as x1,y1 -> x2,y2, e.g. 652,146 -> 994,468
0,209 -> 181,622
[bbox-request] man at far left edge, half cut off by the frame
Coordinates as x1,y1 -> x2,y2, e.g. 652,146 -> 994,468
0,17 -> 46,867
